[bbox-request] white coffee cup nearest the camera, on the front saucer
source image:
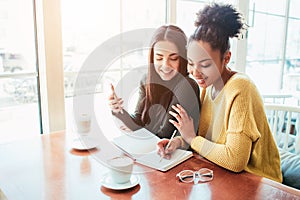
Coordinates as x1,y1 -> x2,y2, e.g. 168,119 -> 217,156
107,156 -> 133,184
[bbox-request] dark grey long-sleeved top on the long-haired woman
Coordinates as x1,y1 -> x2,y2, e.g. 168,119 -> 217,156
114,74 -> 201,138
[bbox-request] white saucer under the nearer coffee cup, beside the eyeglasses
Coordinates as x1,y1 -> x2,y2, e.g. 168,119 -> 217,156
100,173 -> 140,190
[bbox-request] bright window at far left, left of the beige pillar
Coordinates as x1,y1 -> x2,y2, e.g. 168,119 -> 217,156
0,0 -> 41,143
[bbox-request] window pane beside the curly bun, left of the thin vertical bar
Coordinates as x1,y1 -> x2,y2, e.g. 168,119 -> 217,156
246,0 -> 286,93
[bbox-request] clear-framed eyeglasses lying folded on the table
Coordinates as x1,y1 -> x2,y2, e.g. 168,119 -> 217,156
176,168 -> 214,184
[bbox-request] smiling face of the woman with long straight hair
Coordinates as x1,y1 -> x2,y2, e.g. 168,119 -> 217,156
153,41 -> 180,81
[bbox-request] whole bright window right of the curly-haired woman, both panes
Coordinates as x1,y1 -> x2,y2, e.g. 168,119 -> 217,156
246,0 -> 300,95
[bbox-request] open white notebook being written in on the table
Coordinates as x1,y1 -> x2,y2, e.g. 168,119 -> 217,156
113,128 -> 193,171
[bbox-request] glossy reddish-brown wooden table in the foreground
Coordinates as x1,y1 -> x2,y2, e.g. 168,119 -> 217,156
0,132 -> 300,200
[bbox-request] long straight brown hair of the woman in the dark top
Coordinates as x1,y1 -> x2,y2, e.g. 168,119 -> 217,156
142,25 -> 188,124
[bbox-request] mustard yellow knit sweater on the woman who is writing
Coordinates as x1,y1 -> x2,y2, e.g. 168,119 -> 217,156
191,73 -> 282,182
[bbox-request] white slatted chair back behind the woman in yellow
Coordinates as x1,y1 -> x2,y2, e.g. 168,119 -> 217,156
265,103 -> 300,154
